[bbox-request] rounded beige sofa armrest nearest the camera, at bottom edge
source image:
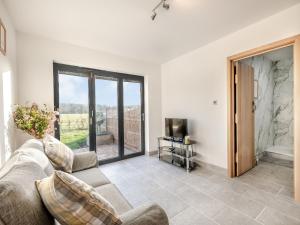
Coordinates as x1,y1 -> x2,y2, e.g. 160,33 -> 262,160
120,204 -> 169,225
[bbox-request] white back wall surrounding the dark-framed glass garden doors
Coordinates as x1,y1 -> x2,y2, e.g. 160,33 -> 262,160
17,33 -> 161,154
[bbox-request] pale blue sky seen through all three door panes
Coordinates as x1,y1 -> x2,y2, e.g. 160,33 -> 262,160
59,74 -> 140,106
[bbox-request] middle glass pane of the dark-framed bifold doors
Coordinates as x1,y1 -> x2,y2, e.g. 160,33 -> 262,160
95,78 -> 119,161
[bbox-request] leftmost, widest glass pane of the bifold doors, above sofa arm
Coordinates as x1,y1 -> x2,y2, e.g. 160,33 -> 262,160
58,73 -> 89,152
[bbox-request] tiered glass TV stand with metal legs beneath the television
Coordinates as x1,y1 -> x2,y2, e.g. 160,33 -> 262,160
158,137 -> 196,172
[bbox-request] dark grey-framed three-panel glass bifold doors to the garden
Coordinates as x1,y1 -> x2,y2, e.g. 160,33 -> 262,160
53,63 -> 145,164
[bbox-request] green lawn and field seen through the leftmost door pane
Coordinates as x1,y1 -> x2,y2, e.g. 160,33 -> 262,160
60,114 -> 89,150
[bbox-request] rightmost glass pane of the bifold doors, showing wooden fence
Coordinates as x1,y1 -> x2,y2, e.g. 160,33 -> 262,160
123,81 -> 142,155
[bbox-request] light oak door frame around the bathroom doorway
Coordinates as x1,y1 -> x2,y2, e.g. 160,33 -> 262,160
227,35 -> 300,202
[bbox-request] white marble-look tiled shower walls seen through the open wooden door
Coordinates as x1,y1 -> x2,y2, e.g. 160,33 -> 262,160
243,47 -> 294,162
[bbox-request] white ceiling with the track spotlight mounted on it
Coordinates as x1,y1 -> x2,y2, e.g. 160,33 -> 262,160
3,0 -> 300,63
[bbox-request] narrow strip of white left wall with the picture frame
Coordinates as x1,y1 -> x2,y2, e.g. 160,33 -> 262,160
0,0 -> 16,165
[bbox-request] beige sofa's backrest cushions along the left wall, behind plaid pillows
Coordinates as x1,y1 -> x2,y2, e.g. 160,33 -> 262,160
0,140 -> 54,225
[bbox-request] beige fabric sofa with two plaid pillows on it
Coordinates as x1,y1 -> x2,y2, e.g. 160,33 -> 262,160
0,140 -> 168,225
